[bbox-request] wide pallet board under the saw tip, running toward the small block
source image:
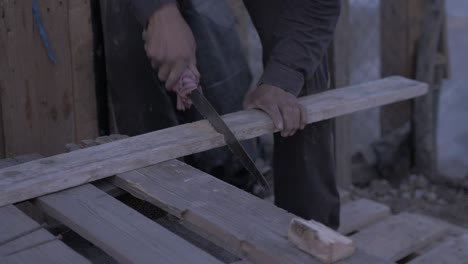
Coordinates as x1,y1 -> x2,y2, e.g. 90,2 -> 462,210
110,160 -> 388,263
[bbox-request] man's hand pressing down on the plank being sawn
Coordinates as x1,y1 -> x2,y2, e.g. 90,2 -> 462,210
244,84 -> 307,137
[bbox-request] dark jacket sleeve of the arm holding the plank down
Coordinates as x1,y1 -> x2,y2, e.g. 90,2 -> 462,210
260,0 -> 340,96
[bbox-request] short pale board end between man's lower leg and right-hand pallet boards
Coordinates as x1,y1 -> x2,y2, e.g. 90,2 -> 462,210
339,199 -> 390,235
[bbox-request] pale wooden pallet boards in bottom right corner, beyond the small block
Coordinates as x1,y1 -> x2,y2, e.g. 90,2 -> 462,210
340,196 -> 468,264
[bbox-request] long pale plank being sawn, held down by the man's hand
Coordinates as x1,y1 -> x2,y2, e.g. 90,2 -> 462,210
0,77 -> 427,206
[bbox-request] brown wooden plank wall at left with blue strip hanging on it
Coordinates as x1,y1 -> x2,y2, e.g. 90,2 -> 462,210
0,0 -> 98,156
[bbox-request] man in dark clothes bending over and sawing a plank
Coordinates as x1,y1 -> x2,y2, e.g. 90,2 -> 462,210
104,0 -> 340,228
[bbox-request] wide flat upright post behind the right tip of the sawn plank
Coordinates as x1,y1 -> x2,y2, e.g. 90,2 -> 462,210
380,0 -> 424,180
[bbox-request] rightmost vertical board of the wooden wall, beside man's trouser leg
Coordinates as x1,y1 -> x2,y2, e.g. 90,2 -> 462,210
67,0 -> 98,143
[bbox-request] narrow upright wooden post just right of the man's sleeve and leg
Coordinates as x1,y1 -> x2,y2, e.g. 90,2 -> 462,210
331,0 -> 352,188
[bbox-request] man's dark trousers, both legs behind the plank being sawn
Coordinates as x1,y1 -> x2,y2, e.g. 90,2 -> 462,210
101,0 -> 340,229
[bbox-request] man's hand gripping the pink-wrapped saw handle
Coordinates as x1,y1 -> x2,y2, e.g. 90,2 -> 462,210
143,4 -> 200,90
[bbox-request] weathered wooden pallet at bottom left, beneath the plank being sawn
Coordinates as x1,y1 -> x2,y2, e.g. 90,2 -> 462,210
0,150 -> 387,263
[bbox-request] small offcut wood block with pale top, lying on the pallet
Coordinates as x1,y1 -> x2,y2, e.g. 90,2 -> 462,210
288,218 -> 355,263
